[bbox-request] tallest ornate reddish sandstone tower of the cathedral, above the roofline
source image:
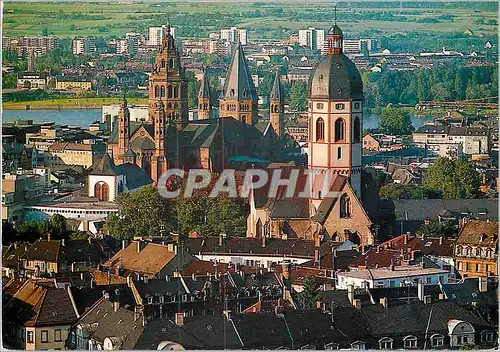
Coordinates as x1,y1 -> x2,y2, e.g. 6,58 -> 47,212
149,25 -> 188,131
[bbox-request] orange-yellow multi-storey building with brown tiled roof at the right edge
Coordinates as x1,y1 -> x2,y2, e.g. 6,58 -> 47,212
455,221 -> 498,277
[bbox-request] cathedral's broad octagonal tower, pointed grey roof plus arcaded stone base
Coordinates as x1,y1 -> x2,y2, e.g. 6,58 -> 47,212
219,44 -> 258,125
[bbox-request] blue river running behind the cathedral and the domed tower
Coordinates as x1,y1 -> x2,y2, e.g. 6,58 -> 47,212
2,109 -> 432,129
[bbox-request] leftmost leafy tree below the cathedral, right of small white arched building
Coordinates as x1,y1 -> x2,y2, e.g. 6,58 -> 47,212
105,186 -> 176,239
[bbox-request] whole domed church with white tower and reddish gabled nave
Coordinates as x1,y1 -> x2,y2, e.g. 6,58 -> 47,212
247,24 -> 378,245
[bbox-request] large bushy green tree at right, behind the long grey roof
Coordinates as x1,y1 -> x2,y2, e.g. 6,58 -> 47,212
423,157 -> 480,199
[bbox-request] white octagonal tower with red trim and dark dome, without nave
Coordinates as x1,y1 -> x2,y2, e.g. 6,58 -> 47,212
308,24 -> 363,214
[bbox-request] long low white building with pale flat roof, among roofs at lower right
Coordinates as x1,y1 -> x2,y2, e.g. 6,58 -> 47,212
337,265 -> 454,290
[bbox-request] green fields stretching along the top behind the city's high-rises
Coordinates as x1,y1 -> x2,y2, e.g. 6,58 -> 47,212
2,1 -> 497,39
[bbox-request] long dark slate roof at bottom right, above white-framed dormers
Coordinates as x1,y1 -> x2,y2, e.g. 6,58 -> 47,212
361,301 -> 488,337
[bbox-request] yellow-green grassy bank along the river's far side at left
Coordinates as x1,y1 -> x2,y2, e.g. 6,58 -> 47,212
2,98 -> 148,110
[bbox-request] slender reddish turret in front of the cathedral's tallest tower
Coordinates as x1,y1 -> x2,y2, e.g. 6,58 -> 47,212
151,98 -> 167,182
